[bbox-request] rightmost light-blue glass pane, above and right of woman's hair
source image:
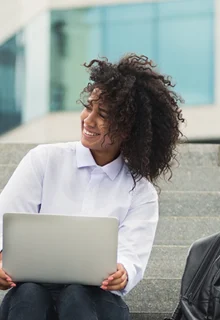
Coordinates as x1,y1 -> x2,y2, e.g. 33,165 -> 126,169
158,0 -> 214,104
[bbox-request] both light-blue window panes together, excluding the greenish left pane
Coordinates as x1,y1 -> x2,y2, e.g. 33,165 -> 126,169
104,0 -> 214,104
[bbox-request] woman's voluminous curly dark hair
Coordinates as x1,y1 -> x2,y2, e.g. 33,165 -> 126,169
80,54 -> 184,187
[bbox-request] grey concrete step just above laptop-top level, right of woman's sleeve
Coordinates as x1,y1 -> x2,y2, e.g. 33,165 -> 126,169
159,188 -> 220,217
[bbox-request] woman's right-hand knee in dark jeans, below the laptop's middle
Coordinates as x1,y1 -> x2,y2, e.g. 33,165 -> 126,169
56,284 -> 98,320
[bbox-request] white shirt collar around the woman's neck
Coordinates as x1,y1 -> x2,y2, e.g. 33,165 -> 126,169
76,142 -> 124,180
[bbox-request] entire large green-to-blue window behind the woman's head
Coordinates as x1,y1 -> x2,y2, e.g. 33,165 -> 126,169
50,0 -> 214,110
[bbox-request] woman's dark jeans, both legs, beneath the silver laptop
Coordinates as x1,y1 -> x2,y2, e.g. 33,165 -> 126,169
0,283 -> 130,320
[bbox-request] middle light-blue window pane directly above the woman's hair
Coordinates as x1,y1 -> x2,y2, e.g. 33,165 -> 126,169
103,3 -> 156,61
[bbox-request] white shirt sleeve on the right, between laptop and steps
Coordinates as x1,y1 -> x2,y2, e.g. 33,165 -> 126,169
114,180 -> 159,296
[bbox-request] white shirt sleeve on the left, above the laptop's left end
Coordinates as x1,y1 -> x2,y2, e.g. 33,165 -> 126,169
0,147 -> 44,250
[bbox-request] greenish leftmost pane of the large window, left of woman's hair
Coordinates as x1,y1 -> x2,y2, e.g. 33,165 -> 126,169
50,8 -> 102,111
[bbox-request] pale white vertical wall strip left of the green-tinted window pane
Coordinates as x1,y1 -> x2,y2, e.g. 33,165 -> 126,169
22,12 -> 50,123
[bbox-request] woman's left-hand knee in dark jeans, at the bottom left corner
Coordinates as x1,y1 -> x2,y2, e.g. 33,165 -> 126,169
0,283 -> 55,320
